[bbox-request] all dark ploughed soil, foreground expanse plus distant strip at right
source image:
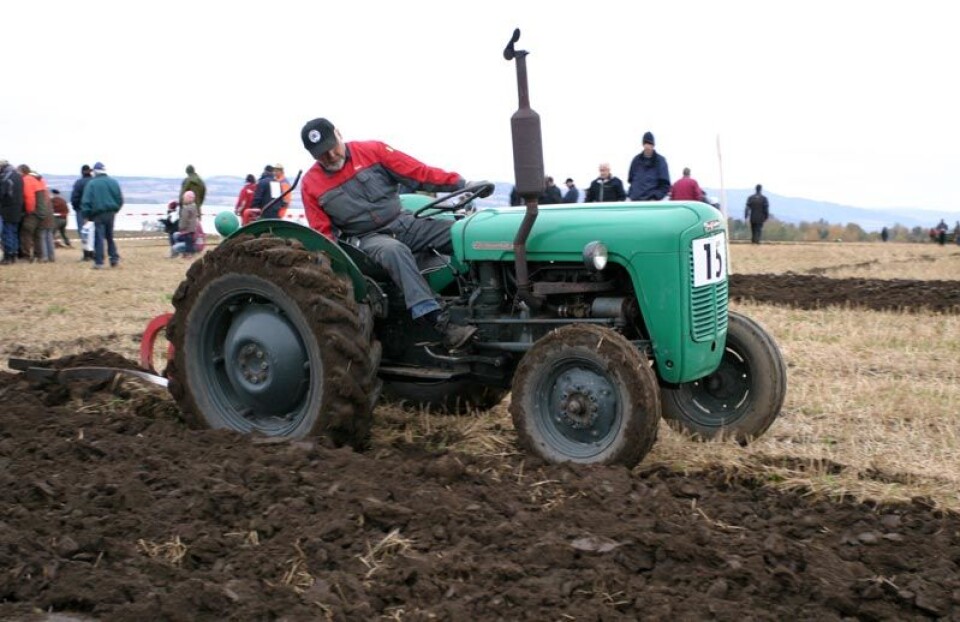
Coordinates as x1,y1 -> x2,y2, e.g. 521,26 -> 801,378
0,275 -> 960,620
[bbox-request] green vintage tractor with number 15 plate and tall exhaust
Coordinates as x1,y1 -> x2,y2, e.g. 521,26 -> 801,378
166,31 -> 786,466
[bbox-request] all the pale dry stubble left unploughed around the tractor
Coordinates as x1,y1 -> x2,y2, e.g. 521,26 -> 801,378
0,239 -> 960,512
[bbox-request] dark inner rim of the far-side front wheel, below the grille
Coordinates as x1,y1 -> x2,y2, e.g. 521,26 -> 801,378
682,348 -> 751,428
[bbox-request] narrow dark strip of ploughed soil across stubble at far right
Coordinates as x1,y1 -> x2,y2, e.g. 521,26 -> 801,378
730,273 -> 960,314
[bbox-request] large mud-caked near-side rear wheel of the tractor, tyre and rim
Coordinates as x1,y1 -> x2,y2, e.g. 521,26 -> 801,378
167,236 -> 380,448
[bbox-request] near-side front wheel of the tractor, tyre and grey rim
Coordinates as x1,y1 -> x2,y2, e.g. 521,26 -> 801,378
510,324 -> 660,467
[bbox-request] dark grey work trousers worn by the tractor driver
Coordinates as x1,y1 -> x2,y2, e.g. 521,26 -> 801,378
360,213 -> 453,309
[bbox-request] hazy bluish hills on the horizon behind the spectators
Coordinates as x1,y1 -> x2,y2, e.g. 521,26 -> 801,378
37,175 -> 960,231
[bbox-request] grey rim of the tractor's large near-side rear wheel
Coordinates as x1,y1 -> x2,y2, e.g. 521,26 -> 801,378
196,292 -> 320,436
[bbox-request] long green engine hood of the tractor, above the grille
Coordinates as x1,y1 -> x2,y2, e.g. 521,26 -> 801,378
453,201 -> 724,261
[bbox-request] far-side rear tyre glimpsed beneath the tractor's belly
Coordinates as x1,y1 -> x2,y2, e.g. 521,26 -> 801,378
383,380 -> 508,415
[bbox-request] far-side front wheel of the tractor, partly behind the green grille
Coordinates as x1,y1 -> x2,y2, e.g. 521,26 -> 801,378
661,312 -> 787,444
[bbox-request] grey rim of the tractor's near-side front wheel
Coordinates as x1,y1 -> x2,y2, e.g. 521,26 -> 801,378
535,359 -> 623,459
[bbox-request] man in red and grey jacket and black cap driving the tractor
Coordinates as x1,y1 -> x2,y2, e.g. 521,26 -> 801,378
300,118 -> 477,350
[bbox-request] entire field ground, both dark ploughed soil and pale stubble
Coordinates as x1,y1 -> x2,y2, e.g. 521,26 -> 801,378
0,240 -> 960,620
